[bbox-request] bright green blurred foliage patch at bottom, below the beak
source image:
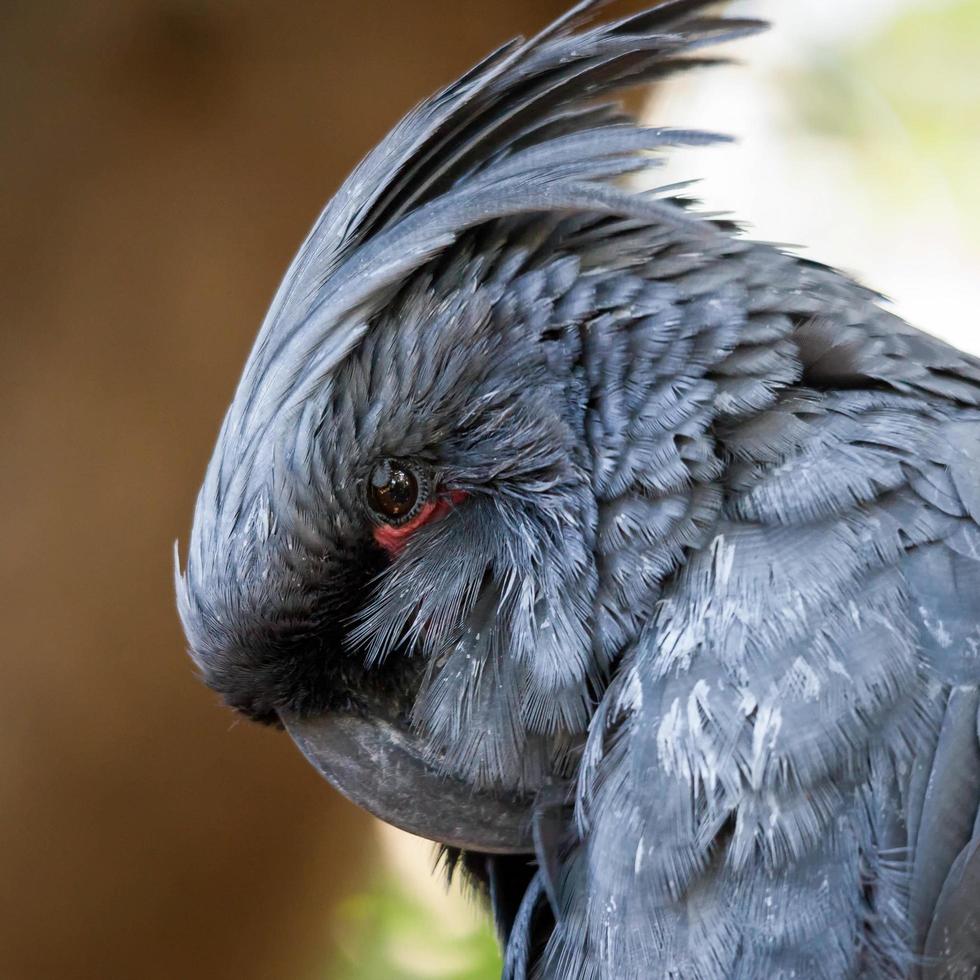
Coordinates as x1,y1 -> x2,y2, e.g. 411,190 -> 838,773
326,880 -> 501,980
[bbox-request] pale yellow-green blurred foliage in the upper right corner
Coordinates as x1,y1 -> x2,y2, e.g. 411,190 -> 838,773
787,0 -> 980,241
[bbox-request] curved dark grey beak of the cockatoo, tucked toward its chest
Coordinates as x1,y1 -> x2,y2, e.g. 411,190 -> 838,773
282,704 -> 534,854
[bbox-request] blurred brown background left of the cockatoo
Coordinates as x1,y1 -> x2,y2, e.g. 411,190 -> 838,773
0,0 -> 564,980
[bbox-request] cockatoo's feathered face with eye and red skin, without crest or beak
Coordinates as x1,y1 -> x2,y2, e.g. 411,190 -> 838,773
178,276 -> 598,844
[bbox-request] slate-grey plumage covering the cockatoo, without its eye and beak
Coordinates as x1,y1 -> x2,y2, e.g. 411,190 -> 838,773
177,0 -> 980,980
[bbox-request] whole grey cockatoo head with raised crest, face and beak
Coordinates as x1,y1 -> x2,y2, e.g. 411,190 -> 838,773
177,0 -> 757,850
